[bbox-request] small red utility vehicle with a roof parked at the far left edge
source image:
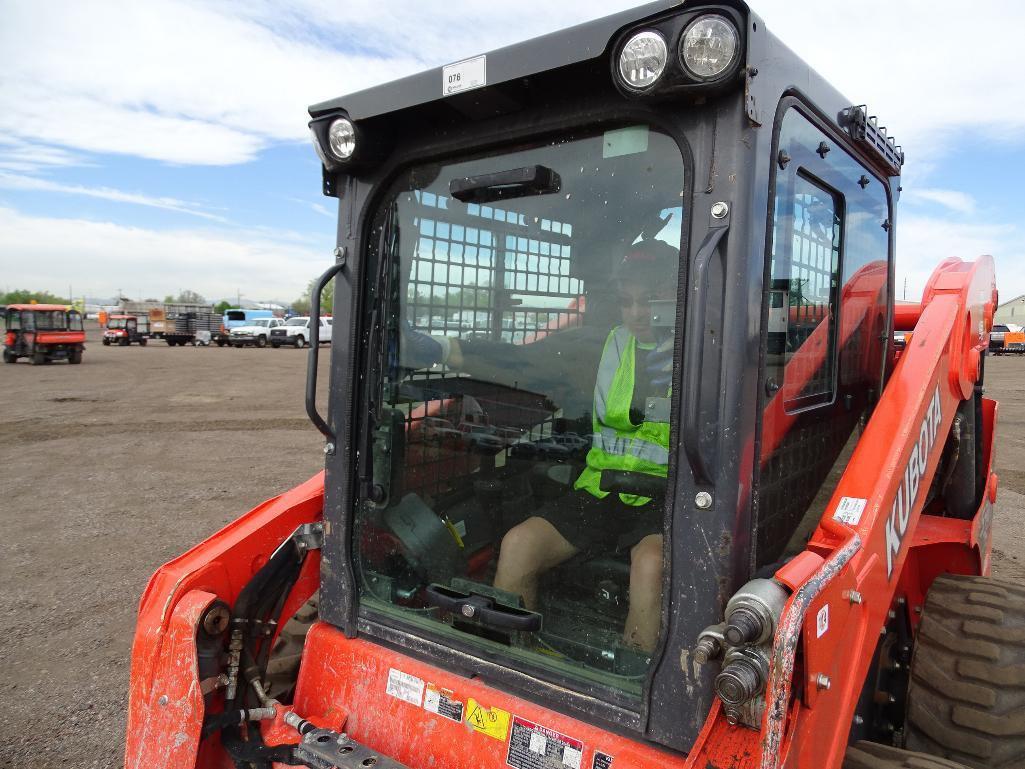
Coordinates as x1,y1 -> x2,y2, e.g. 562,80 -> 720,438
3,305 -> 85,365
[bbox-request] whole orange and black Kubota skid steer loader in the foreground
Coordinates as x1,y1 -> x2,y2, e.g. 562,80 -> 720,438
125,2 -> 1008,769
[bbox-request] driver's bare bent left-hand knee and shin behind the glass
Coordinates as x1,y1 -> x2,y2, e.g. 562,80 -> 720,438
495,517 -> 577,609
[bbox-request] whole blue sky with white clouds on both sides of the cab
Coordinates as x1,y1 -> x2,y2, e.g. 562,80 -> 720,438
0,0 -> 1025,300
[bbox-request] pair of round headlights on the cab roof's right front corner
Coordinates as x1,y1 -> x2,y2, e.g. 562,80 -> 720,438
618,15 -> 740,91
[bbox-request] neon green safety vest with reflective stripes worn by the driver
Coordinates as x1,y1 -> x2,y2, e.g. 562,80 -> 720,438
573,326 -> 669,507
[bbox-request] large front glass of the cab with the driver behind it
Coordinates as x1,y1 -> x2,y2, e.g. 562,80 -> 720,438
355,125 -> 685,695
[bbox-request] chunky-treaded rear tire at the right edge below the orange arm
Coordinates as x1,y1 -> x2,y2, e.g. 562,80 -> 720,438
904,575 -> 1025,769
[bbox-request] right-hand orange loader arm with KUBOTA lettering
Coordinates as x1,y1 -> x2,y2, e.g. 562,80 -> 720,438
752,256 -> 996,769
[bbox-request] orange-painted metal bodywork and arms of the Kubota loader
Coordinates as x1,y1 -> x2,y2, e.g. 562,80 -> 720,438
126,257 -> 996,769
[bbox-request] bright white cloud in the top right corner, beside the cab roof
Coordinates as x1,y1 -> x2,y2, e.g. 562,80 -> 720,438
754,0 -> 1025,171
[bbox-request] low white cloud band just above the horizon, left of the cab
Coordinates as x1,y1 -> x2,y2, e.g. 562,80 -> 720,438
0,207 -> 331,301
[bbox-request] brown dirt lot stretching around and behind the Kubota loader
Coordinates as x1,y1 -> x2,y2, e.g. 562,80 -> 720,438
0,331 -> 1025,769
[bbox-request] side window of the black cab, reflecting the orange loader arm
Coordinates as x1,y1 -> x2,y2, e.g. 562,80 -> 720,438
754,108 -> 890,566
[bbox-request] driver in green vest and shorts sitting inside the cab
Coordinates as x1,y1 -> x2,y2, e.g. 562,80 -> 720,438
405,240 -> 679,652
